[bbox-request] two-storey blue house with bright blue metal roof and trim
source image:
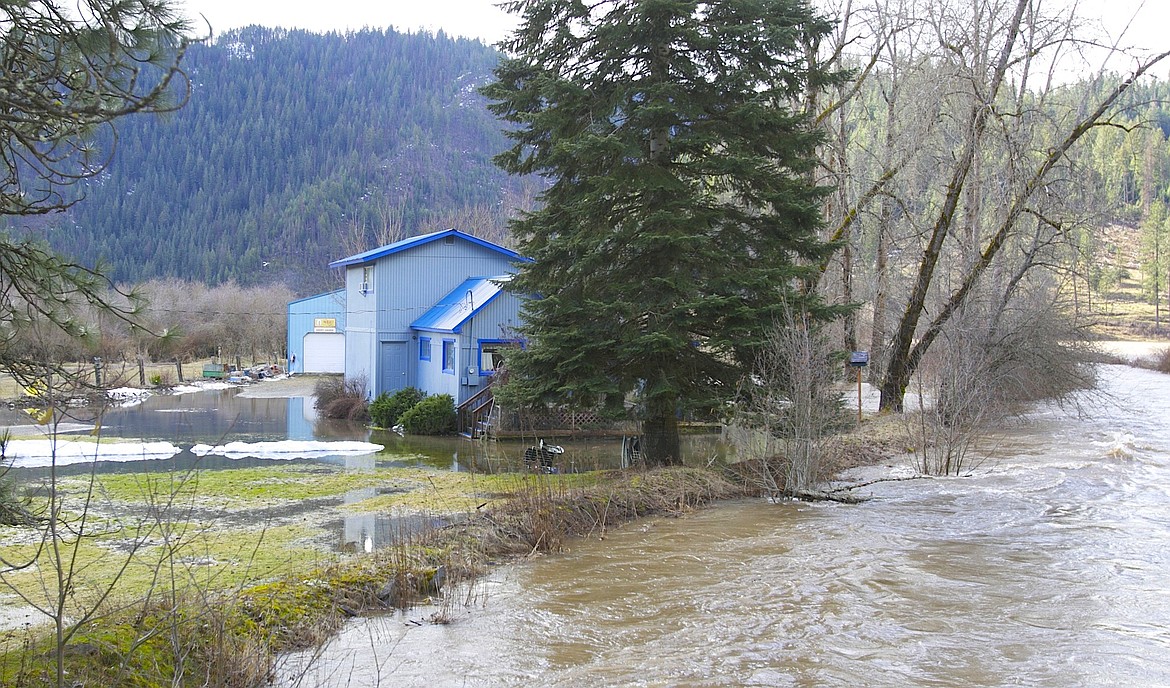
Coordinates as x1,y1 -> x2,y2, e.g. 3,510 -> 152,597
330,229 -> 527,404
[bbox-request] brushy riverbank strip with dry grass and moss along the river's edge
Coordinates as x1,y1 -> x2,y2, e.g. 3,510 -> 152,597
0,468 -> 739,687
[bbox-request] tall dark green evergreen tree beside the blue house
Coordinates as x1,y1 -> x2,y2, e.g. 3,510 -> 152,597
484,0 -> 833,463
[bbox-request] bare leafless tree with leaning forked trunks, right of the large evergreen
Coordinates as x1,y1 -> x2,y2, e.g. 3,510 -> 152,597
821,0 -> 1166,411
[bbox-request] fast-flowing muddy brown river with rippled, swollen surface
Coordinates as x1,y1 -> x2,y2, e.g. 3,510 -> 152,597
282,366 -> 1170,687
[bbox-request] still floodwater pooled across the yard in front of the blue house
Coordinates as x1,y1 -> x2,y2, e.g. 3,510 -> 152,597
12,383 -> 721,551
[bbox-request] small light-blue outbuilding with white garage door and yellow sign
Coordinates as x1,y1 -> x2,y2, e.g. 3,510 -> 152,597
288,289 -> 345,373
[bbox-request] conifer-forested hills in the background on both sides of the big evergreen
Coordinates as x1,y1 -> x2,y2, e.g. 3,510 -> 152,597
6,15 -> 1170,322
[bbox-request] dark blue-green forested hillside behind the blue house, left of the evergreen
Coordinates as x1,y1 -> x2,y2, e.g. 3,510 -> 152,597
22,27 -> 531,293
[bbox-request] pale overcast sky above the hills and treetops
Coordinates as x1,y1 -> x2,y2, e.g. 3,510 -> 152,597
180,0 -> 1170,60
